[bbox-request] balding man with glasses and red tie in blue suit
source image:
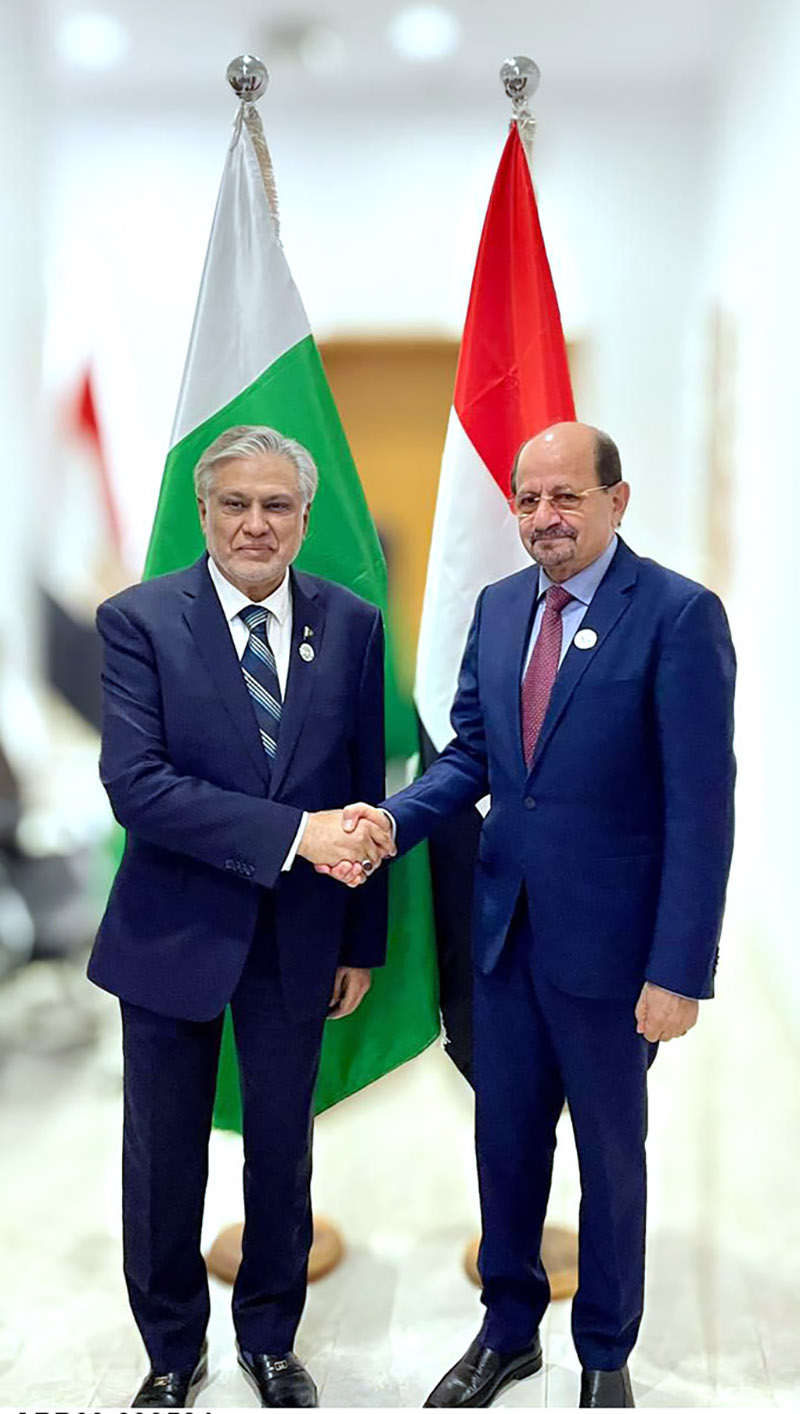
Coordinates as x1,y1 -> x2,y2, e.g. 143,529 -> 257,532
336,423 -> 735,1407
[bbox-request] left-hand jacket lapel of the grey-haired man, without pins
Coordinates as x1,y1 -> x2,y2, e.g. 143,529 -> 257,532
184,556 -> 270,786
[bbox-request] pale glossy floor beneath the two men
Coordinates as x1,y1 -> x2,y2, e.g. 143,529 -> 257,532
0,921 -> 800,1410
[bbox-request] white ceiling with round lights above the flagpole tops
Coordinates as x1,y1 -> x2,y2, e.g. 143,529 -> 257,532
38,0 -> 756,106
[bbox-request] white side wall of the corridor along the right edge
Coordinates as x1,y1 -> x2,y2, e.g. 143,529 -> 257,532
707,0 -> 800,1034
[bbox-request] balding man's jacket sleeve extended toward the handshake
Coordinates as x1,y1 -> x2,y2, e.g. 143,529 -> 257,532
382,594 -> 489,854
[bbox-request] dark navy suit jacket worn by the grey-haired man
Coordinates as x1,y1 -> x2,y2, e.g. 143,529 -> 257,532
89,557 -> 387,1021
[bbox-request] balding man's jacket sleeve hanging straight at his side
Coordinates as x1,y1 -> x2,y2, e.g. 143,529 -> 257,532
645,590 -> 736,997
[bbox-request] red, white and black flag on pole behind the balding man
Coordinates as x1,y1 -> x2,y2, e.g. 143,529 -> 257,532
416,123 -> 575,1079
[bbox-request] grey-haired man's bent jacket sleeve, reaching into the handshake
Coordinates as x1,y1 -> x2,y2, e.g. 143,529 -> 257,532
98,604 -> 302,888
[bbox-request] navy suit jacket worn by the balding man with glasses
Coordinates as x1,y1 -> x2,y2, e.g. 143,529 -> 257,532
386,540 -> 735,998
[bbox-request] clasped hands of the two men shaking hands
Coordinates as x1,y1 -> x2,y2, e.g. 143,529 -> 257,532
297,800 -> 397,888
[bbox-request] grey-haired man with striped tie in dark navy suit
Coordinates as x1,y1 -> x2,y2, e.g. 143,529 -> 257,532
89,427 -> 393,1407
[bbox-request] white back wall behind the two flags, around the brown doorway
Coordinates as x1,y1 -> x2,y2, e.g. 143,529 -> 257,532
48,90 -> 707,571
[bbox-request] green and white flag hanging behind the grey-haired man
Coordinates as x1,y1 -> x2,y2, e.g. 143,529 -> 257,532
144,102 -> 440,1130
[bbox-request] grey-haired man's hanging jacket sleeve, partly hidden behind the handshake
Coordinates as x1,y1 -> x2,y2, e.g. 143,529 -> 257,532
341,611 -> 389,967
